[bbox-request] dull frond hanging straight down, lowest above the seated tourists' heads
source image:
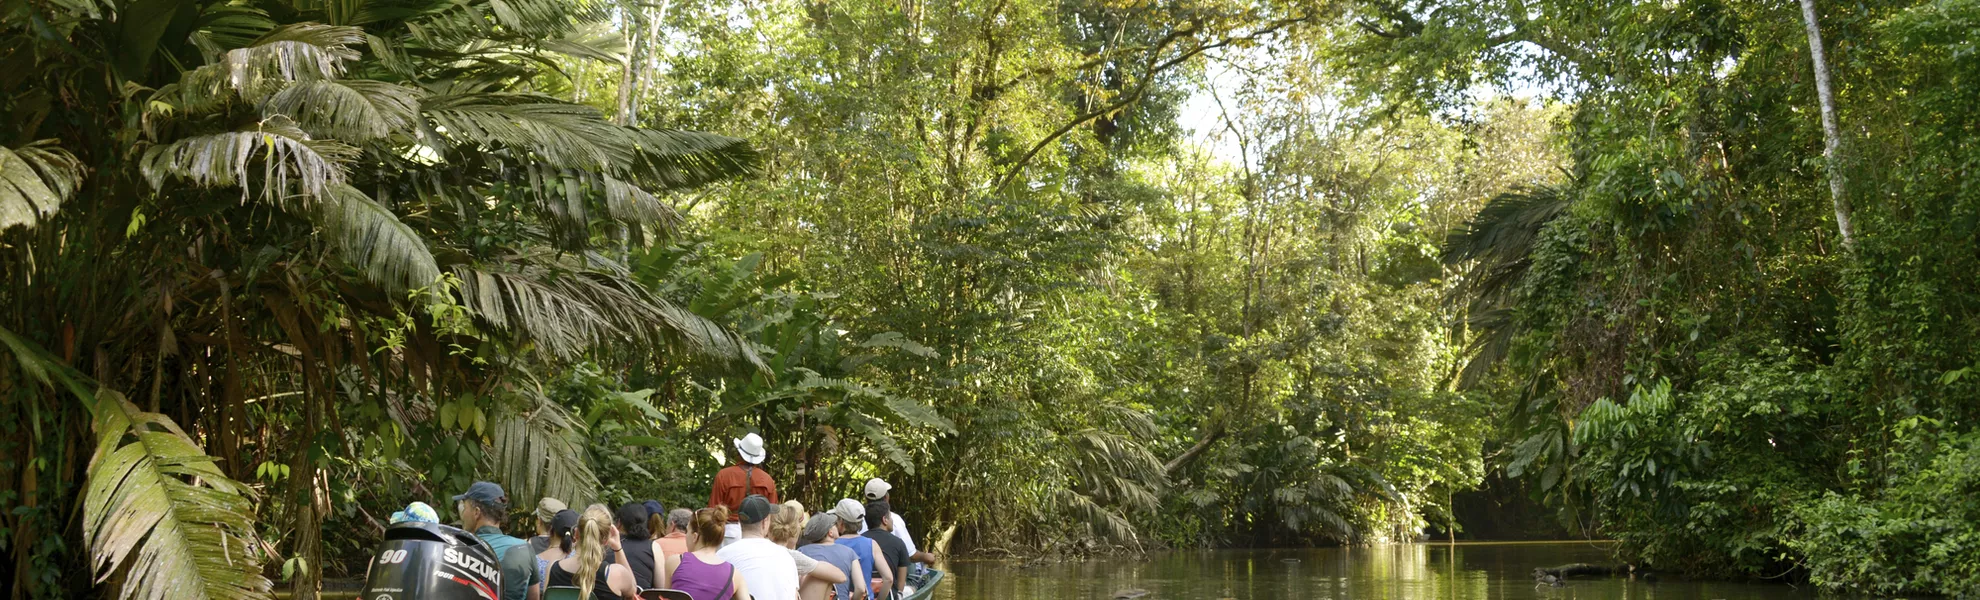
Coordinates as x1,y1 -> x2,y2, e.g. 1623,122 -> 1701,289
487,390 -> 598,507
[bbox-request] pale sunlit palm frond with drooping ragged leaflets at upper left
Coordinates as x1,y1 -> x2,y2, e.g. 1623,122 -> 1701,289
139,119 -> 356,198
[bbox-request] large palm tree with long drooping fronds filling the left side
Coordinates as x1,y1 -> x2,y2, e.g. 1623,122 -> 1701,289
0,0 -> 762,598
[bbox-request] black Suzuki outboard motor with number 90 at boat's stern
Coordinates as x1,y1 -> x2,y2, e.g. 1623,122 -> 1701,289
358,523 -> 501,600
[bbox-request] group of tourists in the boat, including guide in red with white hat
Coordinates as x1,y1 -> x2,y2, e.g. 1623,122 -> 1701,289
427,434 -> 935,600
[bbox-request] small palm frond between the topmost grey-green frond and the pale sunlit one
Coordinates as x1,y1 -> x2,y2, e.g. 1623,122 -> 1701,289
261,79 -> 420,143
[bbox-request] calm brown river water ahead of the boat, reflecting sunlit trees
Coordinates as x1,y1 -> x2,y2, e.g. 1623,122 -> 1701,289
935,543 -> 1816,600
